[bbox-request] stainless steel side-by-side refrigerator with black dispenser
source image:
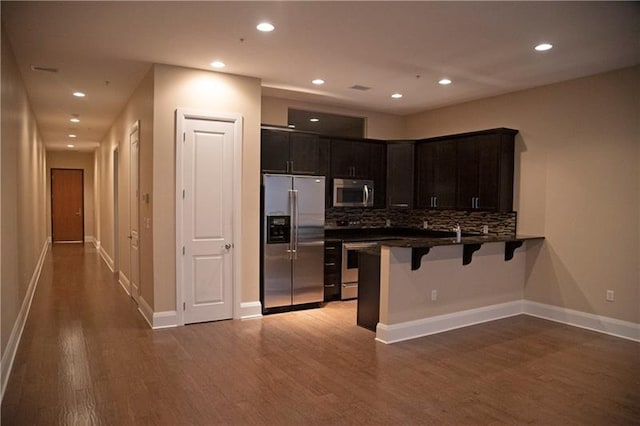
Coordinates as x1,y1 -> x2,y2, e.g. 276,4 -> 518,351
261,174 -> 325,313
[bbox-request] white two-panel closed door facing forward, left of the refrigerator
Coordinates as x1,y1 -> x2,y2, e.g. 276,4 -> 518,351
180,118 -> 235,324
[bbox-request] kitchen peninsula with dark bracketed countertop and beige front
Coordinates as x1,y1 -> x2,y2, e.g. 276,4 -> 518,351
358,235 -> 543,343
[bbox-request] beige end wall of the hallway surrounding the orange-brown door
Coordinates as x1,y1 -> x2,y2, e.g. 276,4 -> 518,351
46,151 -> 96,240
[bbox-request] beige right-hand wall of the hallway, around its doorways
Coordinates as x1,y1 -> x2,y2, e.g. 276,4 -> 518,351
97,69 -> 153,307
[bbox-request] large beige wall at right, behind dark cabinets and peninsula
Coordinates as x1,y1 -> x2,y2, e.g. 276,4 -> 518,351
405,67 -> 640,323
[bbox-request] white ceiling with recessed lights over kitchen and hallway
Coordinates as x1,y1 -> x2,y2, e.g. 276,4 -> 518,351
1,1 -> 640,149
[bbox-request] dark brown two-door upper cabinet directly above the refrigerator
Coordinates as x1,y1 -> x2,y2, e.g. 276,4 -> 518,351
260,129 -> 327,175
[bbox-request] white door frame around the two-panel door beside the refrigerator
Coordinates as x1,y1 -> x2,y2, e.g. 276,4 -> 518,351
175,108 -> 242,325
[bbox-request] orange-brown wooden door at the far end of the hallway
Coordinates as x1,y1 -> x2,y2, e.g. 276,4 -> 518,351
51,169 -> 84,242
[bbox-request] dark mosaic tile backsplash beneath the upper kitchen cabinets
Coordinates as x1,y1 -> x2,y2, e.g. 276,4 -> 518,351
325,208 -> 518,236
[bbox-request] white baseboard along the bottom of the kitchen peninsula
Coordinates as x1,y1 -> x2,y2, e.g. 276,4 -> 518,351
376,300 -> 523,344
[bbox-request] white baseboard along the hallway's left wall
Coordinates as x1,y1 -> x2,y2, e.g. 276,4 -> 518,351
0,238 -> 50,401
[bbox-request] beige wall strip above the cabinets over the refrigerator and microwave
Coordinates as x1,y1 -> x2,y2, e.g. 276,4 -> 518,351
262,96 -> 404,139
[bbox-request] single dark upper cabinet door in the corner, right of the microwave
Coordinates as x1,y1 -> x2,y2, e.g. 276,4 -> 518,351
386,143 -> 414,208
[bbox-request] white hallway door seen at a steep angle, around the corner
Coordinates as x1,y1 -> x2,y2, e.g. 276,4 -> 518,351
129,121 -> 140,303
